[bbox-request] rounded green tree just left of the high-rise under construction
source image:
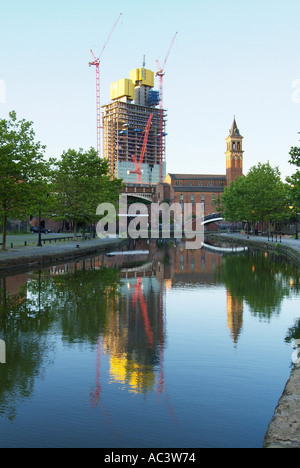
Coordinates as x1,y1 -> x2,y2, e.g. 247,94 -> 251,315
53,148 -> 122,238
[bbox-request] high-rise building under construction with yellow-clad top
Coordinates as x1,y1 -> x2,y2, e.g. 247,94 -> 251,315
103,68 -> 166,184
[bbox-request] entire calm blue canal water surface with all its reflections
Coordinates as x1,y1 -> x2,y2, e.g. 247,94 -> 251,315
0,239 -> 300,448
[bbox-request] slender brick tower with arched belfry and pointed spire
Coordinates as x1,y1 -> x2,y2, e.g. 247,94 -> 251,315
225,117 -> 244,187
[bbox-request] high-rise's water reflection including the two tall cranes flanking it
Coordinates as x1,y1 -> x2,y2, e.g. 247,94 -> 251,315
90,267 -> 177,422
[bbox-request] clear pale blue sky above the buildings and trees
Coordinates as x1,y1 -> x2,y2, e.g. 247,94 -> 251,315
0,0 -> 300,177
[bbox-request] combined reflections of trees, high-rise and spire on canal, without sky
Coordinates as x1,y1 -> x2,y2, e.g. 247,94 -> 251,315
0,242 -> 299,420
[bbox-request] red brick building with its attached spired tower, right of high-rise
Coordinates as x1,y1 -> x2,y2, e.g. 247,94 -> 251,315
156,118 -> 243,215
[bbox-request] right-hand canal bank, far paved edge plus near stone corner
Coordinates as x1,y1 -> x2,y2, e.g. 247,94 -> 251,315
209,234 -> 300,449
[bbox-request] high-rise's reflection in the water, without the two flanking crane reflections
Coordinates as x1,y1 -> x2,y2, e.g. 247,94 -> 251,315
103,271 -> 164,393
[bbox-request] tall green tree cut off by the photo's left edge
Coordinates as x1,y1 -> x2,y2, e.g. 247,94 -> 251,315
0,111 -> 49,250
